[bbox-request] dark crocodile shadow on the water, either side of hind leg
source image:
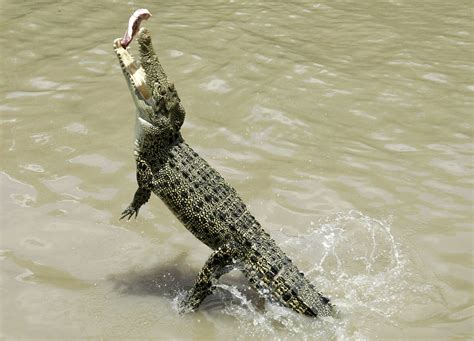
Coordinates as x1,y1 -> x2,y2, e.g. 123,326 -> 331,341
107,253 -> 264,310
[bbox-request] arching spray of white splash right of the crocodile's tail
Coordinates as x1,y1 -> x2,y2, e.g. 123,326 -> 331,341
277,207 -> 431,325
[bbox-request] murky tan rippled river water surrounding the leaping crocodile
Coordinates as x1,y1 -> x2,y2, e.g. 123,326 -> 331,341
0,0 -> 474,340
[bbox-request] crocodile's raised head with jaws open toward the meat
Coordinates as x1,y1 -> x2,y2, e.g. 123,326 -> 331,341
114,28 -> 185,145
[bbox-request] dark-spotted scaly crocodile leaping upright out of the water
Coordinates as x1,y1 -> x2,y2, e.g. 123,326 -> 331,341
113,18 -> 335,317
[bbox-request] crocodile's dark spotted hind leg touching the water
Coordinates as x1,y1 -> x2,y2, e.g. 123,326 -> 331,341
179,244 -> 235,313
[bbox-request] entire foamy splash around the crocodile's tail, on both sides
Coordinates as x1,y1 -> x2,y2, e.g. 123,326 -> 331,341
179,211 -> 432,340
